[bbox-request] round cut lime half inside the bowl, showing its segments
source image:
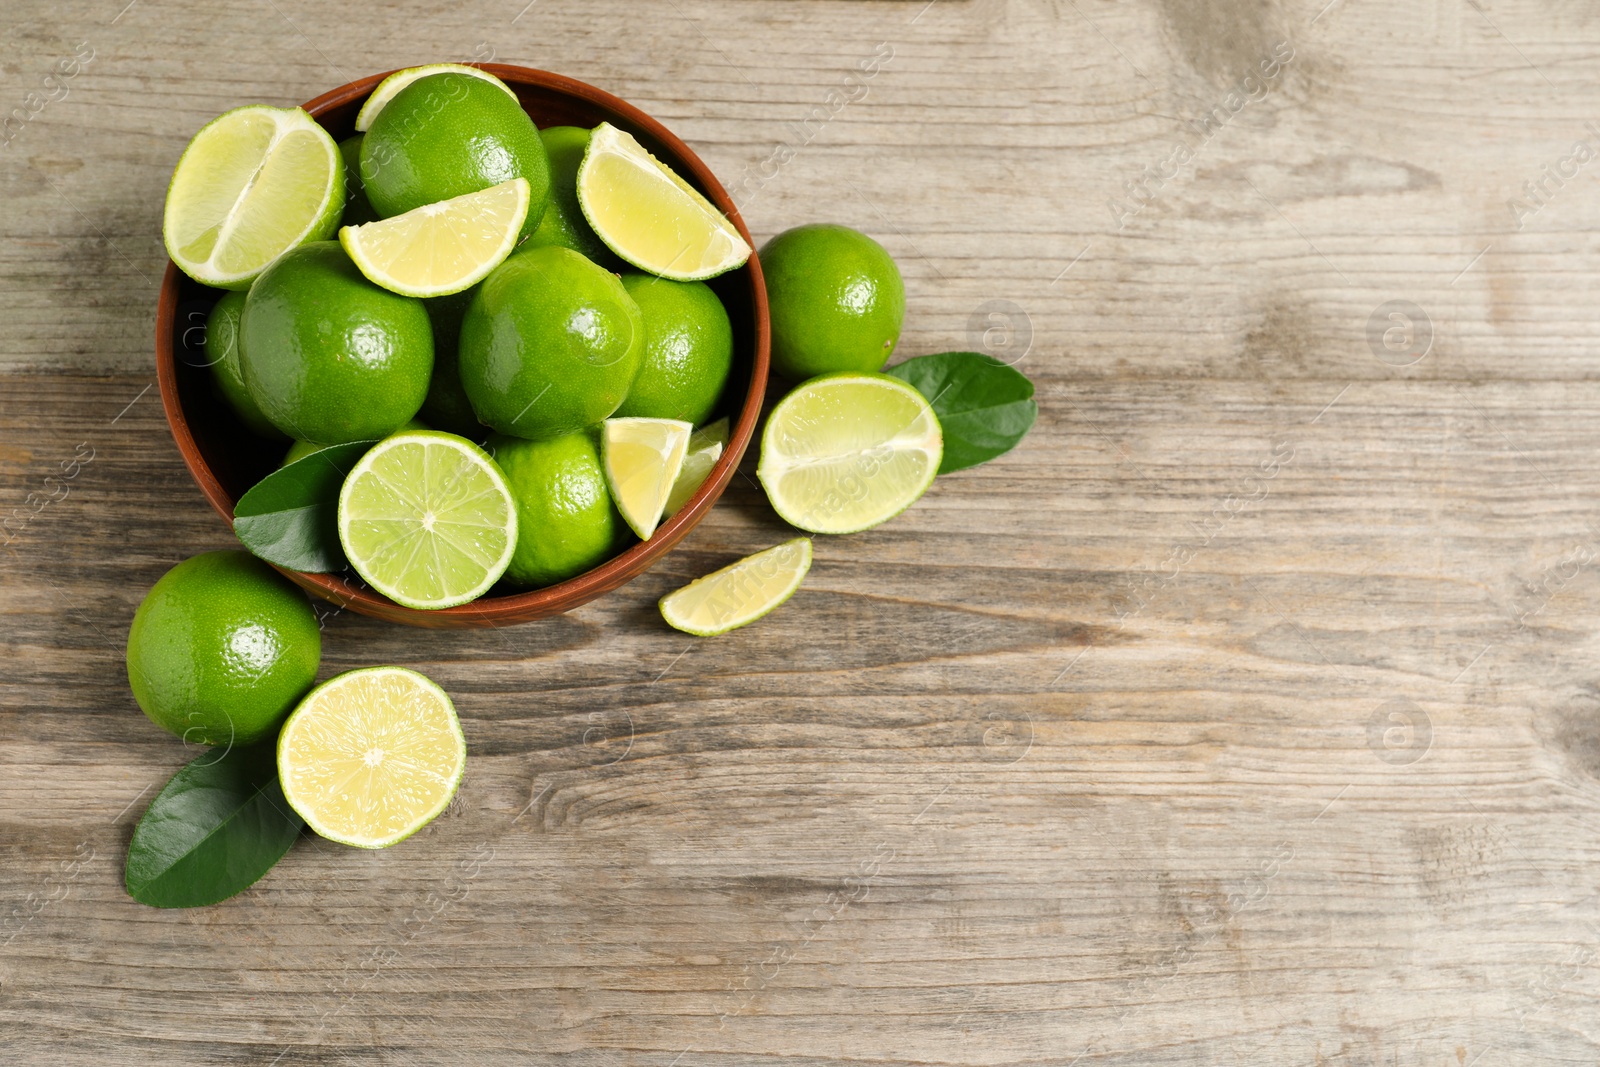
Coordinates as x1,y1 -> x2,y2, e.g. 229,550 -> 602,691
339,430 -> 517,608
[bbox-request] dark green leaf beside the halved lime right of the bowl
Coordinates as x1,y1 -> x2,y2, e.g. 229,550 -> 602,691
886,352 -> 1038,474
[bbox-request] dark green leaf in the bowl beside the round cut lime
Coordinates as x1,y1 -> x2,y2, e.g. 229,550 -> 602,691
234,442 -> 376,573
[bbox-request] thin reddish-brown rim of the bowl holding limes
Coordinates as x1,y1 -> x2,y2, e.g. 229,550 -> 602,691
155,62 -> 771,629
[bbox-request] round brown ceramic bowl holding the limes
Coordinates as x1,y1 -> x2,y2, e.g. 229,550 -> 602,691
155,64 -> 770,629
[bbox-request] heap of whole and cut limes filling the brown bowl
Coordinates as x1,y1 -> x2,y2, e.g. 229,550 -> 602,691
175,64 -> 750,609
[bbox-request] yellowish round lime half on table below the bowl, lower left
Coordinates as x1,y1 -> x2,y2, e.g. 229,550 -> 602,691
278,667 -> 467,848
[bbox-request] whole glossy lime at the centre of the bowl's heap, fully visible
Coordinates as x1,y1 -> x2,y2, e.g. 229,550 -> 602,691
461,245 -> 645,438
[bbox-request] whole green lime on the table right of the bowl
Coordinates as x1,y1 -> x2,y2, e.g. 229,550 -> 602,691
762,222 -> 906,381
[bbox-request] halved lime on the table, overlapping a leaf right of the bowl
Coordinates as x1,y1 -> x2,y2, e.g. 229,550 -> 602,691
755,373 -> 944,534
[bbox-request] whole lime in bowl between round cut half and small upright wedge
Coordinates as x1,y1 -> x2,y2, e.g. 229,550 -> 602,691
488,430 -> 622,585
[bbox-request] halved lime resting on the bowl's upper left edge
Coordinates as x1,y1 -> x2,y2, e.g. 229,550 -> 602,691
162,104 -> 344,290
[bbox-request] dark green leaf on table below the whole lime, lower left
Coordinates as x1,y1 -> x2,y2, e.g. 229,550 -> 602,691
126,739 -> 306,907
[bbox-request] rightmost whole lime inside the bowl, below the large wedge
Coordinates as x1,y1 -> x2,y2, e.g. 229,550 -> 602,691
616,274 -> 733,424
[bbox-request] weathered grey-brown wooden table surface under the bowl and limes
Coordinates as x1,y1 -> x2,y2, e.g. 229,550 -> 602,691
0,0 -> 1600,1067
